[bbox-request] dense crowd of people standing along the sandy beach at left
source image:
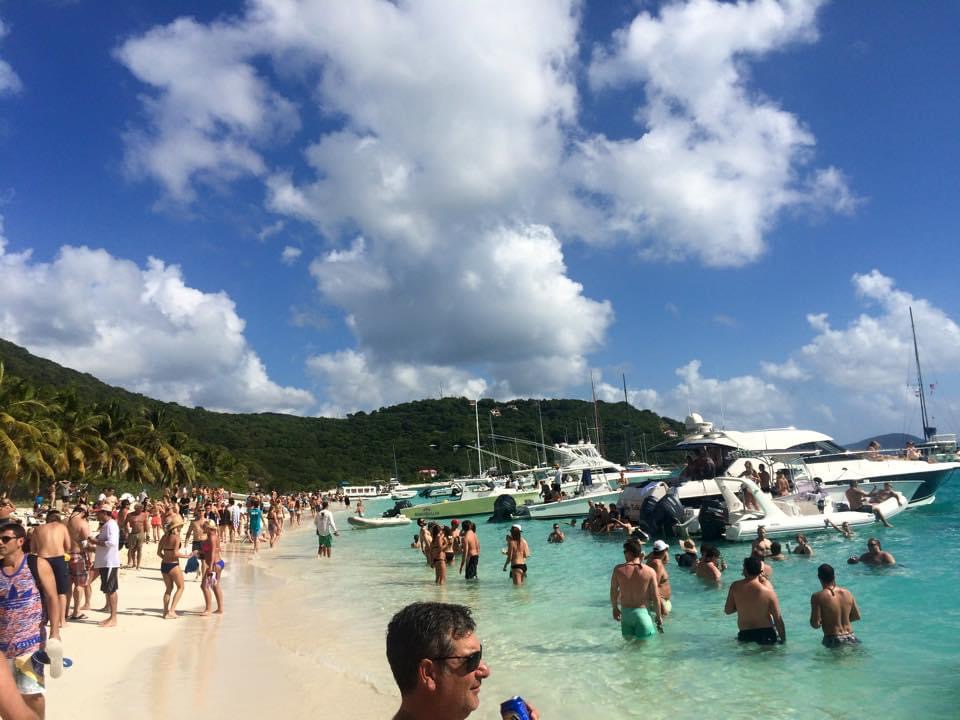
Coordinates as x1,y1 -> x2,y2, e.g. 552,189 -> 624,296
0,483 -> 352,718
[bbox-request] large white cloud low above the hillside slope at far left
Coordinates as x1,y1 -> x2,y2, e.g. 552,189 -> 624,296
0,217 -> 315,413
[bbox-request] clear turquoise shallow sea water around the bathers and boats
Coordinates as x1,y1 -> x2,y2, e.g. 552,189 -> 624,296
270,482 -> 960,720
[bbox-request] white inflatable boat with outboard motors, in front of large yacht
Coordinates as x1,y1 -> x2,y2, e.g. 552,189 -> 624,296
715,478 -> 907,542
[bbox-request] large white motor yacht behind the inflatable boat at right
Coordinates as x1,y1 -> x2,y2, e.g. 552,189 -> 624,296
677,413 -> 960,505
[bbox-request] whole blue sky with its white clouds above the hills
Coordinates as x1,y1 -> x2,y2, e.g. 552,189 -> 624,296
0,0 -> 960,441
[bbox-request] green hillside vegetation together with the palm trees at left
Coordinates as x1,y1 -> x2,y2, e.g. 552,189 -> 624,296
0,340 -> 681,495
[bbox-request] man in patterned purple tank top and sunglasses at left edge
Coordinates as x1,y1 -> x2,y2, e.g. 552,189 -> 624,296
0,522 -> 63,718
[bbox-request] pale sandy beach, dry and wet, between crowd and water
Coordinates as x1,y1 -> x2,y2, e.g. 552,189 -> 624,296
47,518 -> 399,720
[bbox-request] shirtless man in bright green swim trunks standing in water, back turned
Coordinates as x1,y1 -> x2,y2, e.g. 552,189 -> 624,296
610,540 -> 663,640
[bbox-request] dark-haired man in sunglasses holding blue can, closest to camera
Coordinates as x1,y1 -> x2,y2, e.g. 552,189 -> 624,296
387,602 -> 540,720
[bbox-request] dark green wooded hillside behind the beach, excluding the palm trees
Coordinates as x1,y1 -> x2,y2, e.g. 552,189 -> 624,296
0,340 -> 682,489
